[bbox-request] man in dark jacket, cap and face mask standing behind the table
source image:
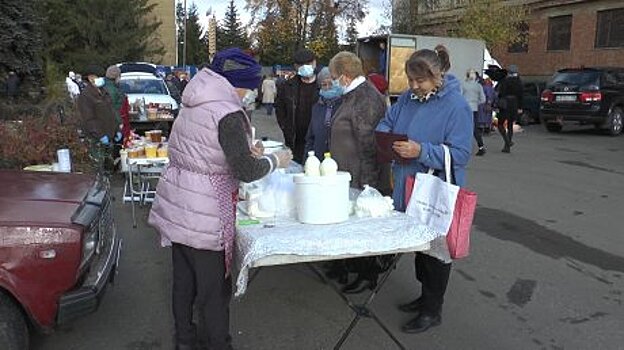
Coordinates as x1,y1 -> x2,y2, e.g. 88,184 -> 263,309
275,49 -> 319,163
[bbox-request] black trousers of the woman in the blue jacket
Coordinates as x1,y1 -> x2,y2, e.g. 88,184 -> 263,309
415,253 -> 451,315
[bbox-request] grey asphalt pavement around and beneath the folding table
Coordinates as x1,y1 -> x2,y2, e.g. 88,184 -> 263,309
32,113 -> 624,350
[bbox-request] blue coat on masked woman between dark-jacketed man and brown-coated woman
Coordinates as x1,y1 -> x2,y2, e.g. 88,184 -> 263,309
303,97 -> 342,161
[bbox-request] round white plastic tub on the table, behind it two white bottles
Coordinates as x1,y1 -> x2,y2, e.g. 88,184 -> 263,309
294,171 -> 351,225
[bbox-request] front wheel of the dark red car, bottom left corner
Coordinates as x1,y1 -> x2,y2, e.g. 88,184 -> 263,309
0,292 -> 28,350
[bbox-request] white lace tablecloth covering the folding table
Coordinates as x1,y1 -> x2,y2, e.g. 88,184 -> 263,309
235,212 -> 437,297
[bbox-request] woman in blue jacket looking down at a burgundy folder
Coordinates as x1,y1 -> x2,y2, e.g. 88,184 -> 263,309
377,45 -> 473,333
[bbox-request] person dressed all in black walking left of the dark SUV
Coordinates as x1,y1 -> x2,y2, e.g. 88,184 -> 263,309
497,64 -> 523,153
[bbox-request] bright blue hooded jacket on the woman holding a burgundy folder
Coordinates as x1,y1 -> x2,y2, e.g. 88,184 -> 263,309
377,74 -> 473,211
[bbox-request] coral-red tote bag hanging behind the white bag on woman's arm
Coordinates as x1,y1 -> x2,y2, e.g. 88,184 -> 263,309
405,176 -> 477,259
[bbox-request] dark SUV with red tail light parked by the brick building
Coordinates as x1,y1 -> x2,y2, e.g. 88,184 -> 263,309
540,68 -> 624,135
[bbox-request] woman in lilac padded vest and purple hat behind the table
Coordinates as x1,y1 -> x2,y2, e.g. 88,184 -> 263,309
148,48 -> 292,350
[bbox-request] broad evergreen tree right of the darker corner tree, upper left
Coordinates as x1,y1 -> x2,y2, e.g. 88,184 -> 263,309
39,0 -> 163,71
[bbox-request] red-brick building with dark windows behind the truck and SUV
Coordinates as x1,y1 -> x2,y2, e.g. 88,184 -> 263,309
395,0 -> 624,80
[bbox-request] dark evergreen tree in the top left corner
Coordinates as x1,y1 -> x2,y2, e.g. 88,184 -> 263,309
0,0 -> 42,75
